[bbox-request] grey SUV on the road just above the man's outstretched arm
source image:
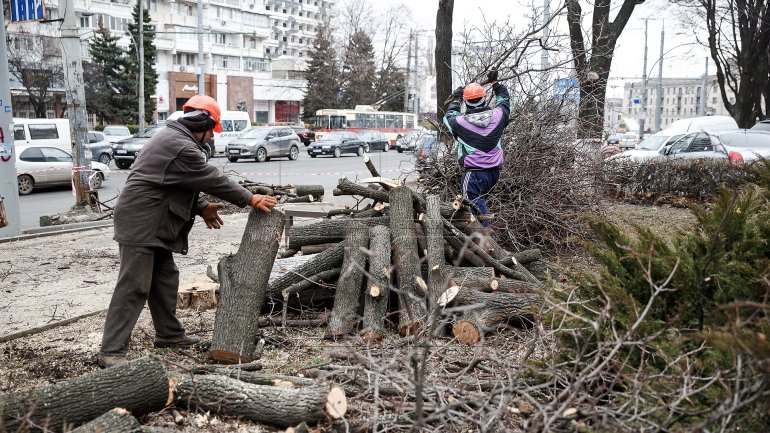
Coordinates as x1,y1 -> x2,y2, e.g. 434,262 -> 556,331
225,126 -> 301,162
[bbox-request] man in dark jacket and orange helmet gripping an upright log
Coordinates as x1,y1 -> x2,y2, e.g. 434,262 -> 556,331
97,95 -> 276,367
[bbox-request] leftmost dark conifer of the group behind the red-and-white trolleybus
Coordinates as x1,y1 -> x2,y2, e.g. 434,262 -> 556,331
302,24 -> 340,123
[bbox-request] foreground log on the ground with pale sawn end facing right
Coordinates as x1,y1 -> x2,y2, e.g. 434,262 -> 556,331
173,373 -> 347,427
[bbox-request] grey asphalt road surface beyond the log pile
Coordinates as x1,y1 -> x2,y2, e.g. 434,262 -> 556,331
20,149 -> 414,229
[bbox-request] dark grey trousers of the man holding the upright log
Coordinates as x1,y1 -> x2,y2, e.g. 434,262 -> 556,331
101,244 -> 184,355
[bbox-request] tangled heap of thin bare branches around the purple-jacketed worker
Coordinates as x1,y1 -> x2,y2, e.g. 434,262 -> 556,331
418,95 -> 600,249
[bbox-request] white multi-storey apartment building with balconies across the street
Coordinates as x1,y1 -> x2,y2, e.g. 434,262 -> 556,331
8,0 -> 336,123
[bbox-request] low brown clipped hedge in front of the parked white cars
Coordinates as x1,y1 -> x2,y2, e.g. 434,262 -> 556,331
603,158 -> 749,203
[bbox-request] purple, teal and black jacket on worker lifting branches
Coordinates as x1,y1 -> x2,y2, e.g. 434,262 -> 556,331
444,83 -> 511,170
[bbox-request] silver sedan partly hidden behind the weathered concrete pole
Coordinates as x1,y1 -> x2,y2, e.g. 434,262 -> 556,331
14,145 -> 110,195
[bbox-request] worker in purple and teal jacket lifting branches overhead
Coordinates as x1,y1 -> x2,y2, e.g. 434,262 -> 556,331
444,70 -> 511,227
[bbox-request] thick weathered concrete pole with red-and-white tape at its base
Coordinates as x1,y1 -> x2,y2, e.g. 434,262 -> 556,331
59,0 -> 91,207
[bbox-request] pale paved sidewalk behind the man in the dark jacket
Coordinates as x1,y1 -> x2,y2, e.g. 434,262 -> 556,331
0,203 -> 337,340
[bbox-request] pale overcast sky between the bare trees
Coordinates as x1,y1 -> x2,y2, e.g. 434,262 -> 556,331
376,0 -> 715,97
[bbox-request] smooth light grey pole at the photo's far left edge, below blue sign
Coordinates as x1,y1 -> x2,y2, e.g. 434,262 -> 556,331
0,14 -> 21,238
